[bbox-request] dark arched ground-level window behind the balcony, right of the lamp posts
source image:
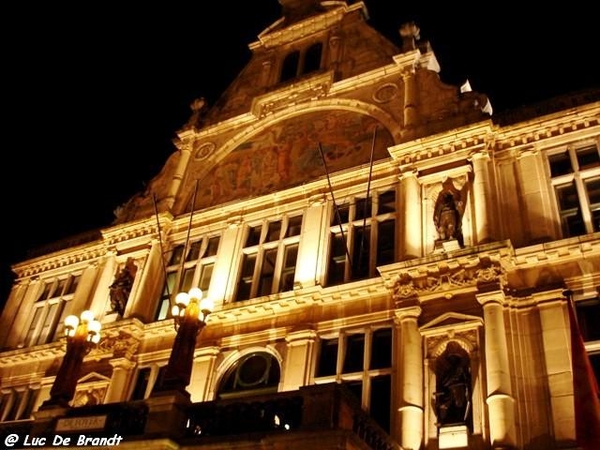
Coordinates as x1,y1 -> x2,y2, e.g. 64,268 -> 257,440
217,352 -> 281,398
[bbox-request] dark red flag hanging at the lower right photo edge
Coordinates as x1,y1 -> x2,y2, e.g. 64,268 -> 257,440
567,295 -> 600,450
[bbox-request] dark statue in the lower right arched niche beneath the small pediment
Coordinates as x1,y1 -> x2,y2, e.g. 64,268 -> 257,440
434,342 -> 471,427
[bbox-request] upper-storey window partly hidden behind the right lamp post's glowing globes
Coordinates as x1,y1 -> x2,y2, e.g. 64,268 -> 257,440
154,236 -> 221,320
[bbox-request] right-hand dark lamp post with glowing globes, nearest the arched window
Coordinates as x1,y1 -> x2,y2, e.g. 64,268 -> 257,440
153,288 -> 214,397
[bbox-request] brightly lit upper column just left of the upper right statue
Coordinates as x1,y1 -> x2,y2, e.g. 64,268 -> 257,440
400,170 -> 423,260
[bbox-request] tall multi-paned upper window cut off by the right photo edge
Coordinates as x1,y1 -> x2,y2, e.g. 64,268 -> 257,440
548,143 -> 600,237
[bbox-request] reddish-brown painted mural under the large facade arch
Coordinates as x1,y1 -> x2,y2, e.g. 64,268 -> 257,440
195,111 -> 393,209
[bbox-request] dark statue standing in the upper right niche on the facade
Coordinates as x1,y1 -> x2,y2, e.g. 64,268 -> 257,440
433,178 -> 467,248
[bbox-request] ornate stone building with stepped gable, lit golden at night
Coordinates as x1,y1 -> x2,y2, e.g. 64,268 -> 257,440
0,0 -> 600,450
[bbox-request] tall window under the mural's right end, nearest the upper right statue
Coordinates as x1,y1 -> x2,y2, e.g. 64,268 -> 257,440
326,189 -> 396,286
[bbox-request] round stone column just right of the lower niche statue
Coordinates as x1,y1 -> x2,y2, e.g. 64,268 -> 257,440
477,291 -> 516,449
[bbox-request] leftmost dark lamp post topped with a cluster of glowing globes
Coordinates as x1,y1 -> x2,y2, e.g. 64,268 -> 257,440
42,311 -> 102,407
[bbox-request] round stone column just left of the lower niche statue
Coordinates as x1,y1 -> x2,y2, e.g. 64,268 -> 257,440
394,306 -> 423,449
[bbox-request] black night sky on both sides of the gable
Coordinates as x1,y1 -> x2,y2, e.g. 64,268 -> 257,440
0,0 -> 600,304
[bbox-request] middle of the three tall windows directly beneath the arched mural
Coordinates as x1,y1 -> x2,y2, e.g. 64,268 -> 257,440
235,215 -> 302,301
